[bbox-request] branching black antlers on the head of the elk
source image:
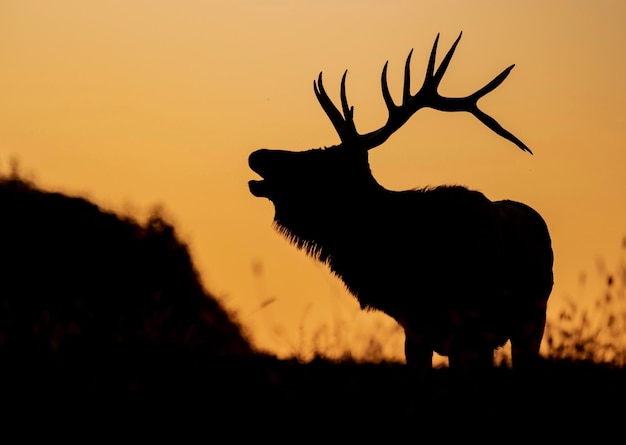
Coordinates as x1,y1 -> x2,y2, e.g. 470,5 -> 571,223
313,32 -> 532,154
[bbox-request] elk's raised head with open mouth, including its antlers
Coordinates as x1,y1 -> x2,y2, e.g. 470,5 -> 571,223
248,33 -> 532,259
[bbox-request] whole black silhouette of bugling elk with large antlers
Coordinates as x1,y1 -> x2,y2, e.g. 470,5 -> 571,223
248,33 -> 553,372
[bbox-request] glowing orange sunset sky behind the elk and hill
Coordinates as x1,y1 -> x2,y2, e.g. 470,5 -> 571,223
0,0 -> 626,357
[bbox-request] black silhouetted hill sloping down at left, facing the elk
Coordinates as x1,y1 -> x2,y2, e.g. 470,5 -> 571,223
0,178 -> 252,356
